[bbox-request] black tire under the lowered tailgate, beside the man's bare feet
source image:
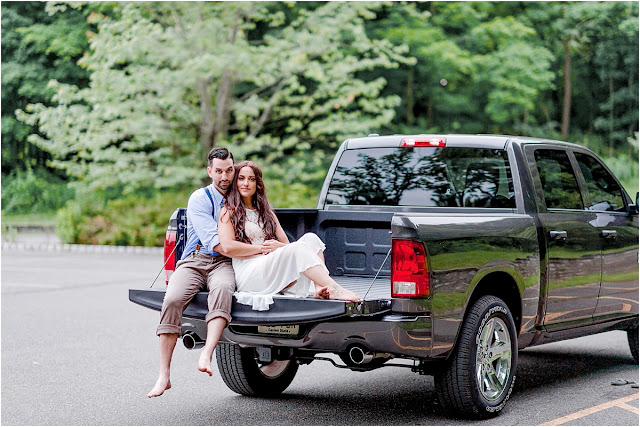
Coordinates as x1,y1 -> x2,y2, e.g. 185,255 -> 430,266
216,343 -> 298,397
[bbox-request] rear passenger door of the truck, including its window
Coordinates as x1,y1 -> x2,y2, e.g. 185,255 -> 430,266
526,146 -> 602,330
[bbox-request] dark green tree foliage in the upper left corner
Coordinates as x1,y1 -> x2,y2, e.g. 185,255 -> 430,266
1,2 -> 89,174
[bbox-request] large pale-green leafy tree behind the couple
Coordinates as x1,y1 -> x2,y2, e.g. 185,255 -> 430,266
19,2 -> 407,196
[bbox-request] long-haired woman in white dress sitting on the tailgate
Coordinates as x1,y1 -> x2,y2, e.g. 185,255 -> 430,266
218,161 -> 361,310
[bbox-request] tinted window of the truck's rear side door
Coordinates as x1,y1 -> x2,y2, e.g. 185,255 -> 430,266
535,150 -> 583,209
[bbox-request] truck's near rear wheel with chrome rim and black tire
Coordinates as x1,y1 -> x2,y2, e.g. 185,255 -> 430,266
434,295 -> 518,419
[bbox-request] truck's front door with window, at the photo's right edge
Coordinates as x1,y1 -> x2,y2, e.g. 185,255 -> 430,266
574,151 -> 638,320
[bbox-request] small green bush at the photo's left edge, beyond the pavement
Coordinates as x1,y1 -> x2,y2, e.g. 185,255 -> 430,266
2,169 -> 74,215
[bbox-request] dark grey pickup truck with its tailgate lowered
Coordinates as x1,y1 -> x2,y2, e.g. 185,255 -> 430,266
129,135 -> 638,418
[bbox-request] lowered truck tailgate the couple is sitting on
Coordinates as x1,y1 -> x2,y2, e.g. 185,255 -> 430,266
129,276 -> 391,325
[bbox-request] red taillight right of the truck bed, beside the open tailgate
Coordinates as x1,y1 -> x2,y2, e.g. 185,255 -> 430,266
391,239 -> 429,298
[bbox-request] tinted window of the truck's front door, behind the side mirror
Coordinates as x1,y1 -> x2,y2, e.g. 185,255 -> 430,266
575,153 -> 625,212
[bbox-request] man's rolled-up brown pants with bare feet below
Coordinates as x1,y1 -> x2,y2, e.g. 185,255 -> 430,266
156,252 -> 236,335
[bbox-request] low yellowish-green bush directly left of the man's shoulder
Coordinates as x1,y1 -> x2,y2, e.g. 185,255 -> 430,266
56,191 -> 190,246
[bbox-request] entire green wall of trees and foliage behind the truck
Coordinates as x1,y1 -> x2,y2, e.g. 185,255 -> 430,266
2,1 -> 638,244
